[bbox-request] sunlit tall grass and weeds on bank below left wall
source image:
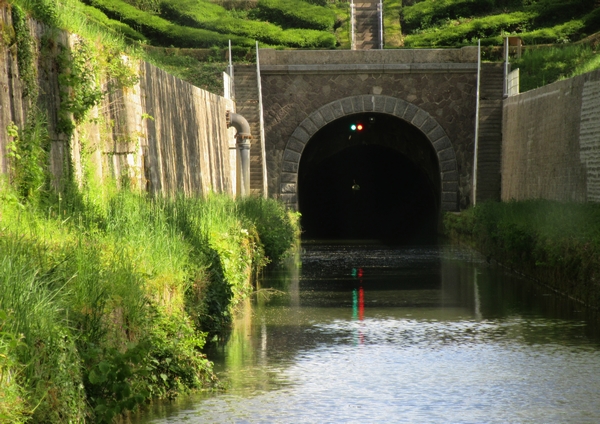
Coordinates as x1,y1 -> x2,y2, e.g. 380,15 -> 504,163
0,186 -> 297,423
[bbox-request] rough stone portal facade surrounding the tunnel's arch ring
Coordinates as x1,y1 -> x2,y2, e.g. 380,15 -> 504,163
259,47 -> 477,210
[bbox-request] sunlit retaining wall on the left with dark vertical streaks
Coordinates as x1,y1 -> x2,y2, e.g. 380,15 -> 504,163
0,7 -> 235,195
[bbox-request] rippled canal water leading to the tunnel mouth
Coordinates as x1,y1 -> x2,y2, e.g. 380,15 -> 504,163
136,243 -> 600,423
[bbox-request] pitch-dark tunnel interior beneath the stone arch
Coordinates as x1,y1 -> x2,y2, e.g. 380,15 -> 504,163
298,114 -> 440,244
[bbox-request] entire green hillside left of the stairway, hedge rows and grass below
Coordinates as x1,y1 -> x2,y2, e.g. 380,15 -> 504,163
8,0 -> 350,92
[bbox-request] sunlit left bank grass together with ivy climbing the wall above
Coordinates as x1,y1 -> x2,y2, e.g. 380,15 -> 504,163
0,0 -> 298,423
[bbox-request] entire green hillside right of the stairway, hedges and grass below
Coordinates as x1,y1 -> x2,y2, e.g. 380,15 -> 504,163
392,0 -> 600,91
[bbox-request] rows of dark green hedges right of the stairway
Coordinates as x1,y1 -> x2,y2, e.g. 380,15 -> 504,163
400,0 -> 600,47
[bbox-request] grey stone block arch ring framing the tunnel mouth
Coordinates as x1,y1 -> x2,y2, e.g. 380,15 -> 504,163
279,95 -> 458,211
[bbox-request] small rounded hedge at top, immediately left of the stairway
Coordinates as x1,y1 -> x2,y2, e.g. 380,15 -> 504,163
251,0 -> 336,31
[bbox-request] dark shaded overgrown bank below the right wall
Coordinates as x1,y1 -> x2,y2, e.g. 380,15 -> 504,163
444,200 -> 600,309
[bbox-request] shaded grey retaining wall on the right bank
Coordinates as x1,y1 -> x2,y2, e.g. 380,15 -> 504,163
502,70 -> 600,202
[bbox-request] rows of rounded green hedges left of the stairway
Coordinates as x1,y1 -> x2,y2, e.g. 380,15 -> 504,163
76,0 -> 336,48
